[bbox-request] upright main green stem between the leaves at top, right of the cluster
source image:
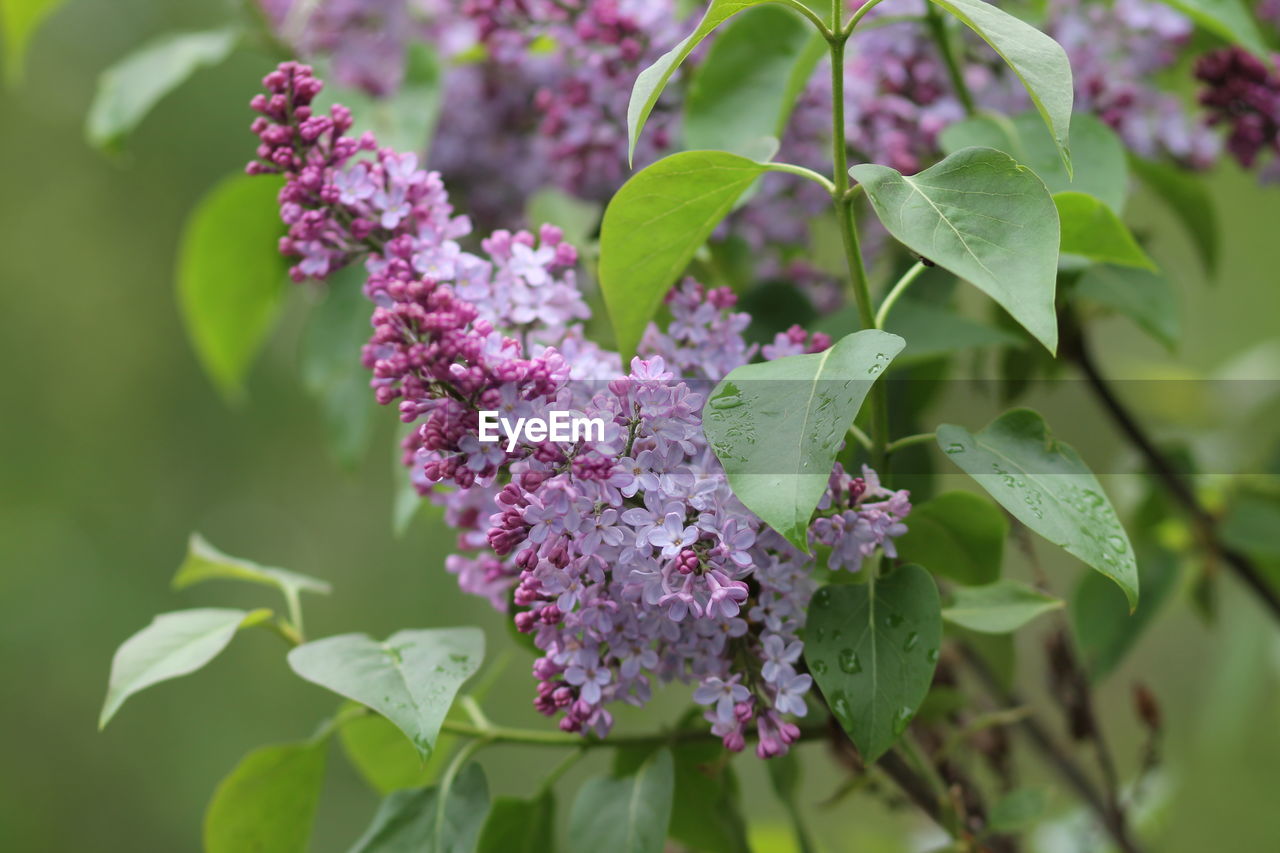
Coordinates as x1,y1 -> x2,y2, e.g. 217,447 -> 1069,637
831,24 -> 888,470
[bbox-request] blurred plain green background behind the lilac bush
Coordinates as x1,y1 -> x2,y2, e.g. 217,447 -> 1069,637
0,0 -> 1280,853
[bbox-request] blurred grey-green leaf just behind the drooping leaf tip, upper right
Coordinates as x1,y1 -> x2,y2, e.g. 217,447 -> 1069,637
938,111 -> 1129,213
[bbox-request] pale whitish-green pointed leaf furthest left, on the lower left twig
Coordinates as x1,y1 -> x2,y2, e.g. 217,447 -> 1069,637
97,607 -> 271,729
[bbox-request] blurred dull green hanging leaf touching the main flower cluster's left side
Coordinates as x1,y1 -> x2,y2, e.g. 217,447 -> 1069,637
300,264 -> 379,466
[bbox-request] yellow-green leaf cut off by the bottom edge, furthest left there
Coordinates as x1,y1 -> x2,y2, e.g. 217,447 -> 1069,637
205,740 -> 328,853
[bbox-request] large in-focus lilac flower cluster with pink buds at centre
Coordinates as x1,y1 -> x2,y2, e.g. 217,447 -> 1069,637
250,63 -> 910,757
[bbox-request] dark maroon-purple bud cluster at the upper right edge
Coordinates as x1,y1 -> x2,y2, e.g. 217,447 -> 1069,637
1196,47 -> 1280,181
